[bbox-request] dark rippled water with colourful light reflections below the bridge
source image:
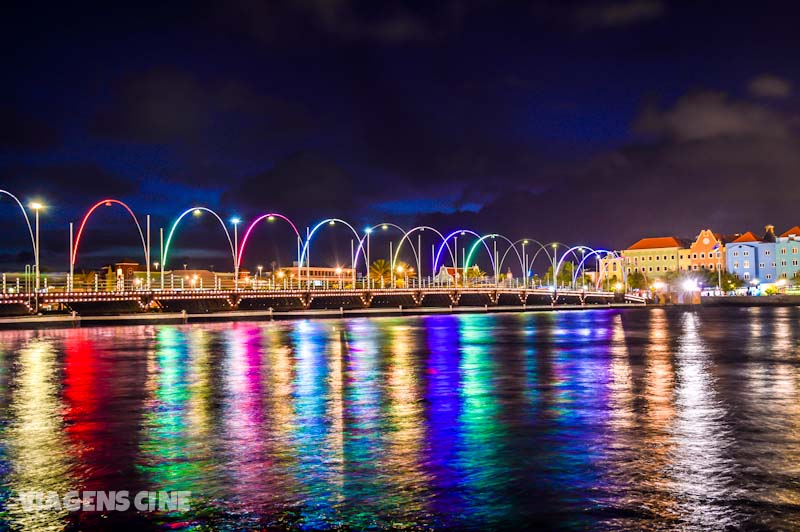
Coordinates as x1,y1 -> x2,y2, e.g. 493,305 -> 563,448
0,308 -> 800,530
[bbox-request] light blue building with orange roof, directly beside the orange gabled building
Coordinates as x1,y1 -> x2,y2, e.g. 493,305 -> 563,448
726,225 -> 777,284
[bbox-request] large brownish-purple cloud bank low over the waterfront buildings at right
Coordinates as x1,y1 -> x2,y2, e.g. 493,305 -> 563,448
418,90 -> 800,248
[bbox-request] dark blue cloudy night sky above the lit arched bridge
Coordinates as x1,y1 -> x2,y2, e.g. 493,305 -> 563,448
0,0 -> 800,271
